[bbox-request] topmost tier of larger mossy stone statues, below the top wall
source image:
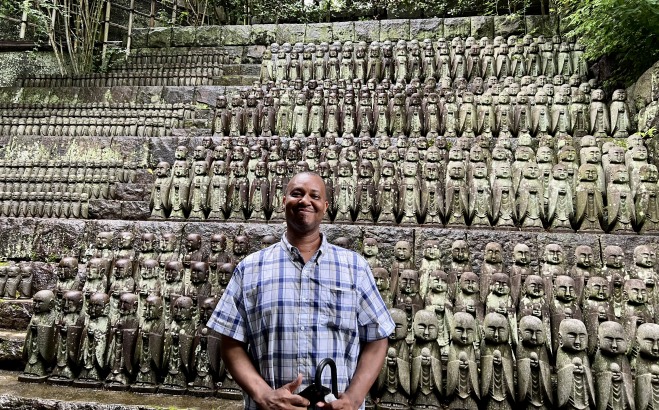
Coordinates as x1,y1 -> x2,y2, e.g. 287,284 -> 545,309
261,36 -> 588,82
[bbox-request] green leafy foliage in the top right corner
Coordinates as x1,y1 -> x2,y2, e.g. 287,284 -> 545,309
556,0 -> 659,86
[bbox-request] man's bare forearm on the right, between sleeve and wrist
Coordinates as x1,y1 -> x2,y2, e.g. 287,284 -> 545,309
345,338 -> 389,408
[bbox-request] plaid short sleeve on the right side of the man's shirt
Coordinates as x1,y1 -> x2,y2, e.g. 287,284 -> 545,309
357,265 -> 395,342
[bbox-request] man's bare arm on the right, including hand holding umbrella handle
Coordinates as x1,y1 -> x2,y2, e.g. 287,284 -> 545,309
318,338 -> 389,410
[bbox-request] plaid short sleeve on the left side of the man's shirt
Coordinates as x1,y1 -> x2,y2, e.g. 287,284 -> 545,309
206,265 -> 248,343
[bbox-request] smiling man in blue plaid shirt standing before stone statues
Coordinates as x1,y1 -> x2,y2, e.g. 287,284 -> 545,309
208,172 -> 394,410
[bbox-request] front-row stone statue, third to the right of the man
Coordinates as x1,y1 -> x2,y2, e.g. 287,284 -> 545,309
446,312 -> 481,410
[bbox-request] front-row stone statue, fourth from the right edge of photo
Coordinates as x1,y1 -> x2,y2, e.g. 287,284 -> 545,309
517,316 -> 554,410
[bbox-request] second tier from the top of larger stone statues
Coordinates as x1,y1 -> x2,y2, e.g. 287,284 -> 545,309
212,81 -> 634,142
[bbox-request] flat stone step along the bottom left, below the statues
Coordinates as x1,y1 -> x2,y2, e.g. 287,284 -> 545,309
0,370 -> 243,410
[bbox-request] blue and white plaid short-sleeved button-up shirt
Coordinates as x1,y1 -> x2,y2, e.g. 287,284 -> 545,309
208,235 -> 394,409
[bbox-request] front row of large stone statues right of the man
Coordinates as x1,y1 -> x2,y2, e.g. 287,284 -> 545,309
370,309 -> 659,410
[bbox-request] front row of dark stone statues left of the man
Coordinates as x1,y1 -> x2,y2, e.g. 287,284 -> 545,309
19,290 -> 241,399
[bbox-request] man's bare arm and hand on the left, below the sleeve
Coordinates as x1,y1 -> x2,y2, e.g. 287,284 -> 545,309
220,335 -> 309,410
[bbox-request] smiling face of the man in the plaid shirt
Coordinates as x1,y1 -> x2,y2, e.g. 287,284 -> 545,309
284,174 -> 329,233
